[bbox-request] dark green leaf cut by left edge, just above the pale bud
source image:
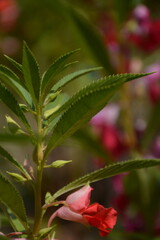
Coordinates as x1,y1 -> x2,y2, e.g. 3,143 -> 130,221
0,83 -> 31,131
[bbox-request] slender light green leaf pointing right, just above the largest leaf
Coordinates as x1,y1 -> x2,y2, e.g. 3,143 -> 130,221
52,68 -> 102,91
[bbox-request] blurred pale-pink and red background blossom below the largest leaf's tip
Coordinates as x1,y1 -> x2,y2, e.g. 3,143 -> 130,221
90,104 -> 128,159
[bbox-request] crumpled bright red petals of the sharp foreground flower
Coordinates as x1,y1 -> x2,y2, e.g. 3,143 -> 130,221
82,203 -> 117,237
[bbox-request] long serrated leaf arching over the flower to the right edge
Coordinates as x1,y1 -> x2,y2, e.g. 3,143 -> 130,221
49,159 -> 160,202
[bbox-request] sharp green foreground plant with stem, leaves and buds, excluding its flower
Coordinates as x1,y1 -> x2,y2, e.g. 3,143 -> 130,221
0,43 -> 160,240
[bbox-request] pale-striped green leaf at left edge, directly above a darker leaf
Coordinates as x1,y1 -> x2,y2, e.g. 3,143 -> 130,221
0,65 -> 32,105
